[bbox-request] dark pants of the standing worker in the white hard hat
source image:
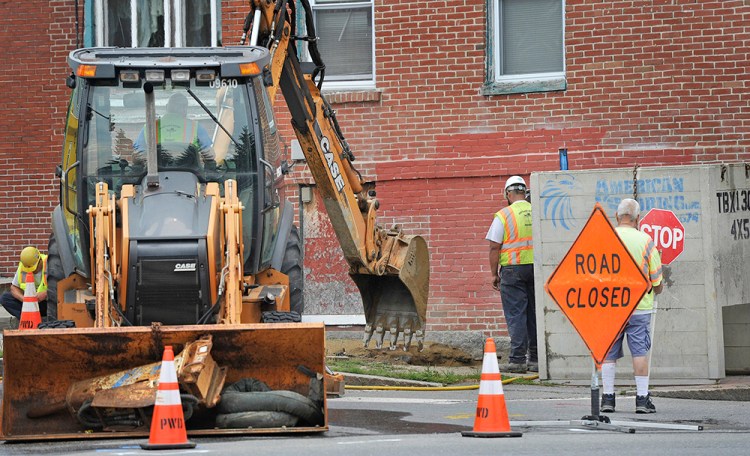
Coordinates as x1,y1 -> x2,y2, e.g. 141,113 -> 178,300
500,264 -> 538,364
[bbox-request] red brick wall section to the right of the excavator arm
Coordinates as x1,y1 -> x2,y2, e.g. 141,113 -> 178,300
282,0 -> 750,342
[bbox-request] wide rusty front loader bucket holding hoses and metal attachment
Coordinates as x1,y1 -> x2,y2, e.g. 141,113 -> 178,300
0,323 -> 328,441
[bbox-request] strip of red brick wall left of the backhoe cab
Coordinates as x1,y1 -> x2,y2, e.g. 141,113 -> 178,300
0,0 -> 82,276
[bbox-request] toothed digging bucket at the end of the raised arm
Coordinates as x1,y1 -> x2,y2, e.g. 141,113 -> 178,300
351,232 -> 430,351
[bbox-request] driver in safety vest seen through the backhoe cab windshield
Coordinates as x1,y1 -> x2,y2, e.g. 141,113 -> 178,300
133,92 -> 213,159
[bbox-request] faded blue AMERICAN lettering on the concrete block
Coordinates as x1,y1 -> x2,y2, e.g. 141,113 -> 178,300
595,177 -> 701,224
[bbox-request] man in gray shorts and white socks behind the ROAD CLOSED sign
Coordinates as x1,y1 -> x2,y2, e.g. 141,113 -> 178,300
600,198 -> 662,413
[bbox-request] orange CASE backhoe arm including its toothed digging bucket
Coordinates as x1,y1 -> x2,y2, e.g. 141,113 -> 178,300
243,0 -> 429,350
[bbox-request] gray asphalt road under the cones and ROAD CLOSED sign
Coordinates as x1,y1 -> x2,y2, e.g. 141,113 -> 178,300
0,384 -> 750,456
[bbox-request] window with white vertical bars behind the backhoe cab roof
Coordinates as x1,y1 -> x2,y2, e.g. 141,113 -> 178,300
84,0 -> 221,47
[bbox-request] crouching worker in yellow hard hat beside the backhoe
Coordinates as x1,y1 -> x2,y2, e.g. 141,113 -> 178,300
0,247 -> 47,320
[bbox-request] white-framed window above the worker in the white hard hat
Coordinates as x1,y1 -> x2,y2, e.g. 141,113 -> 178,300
484,0 -> 566,94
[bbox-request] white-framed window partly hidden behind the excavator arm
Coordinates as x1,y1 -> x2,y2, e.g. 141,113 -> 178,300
306,0 -> 375,89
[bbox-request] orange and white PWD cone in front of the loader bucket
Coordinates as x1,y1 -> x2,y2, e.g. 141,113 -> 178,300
141,345 -> 195,450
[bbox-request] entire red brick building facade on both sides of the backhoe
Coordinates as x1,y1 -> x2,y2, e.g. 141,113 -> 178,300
0,0 -> 750,342
